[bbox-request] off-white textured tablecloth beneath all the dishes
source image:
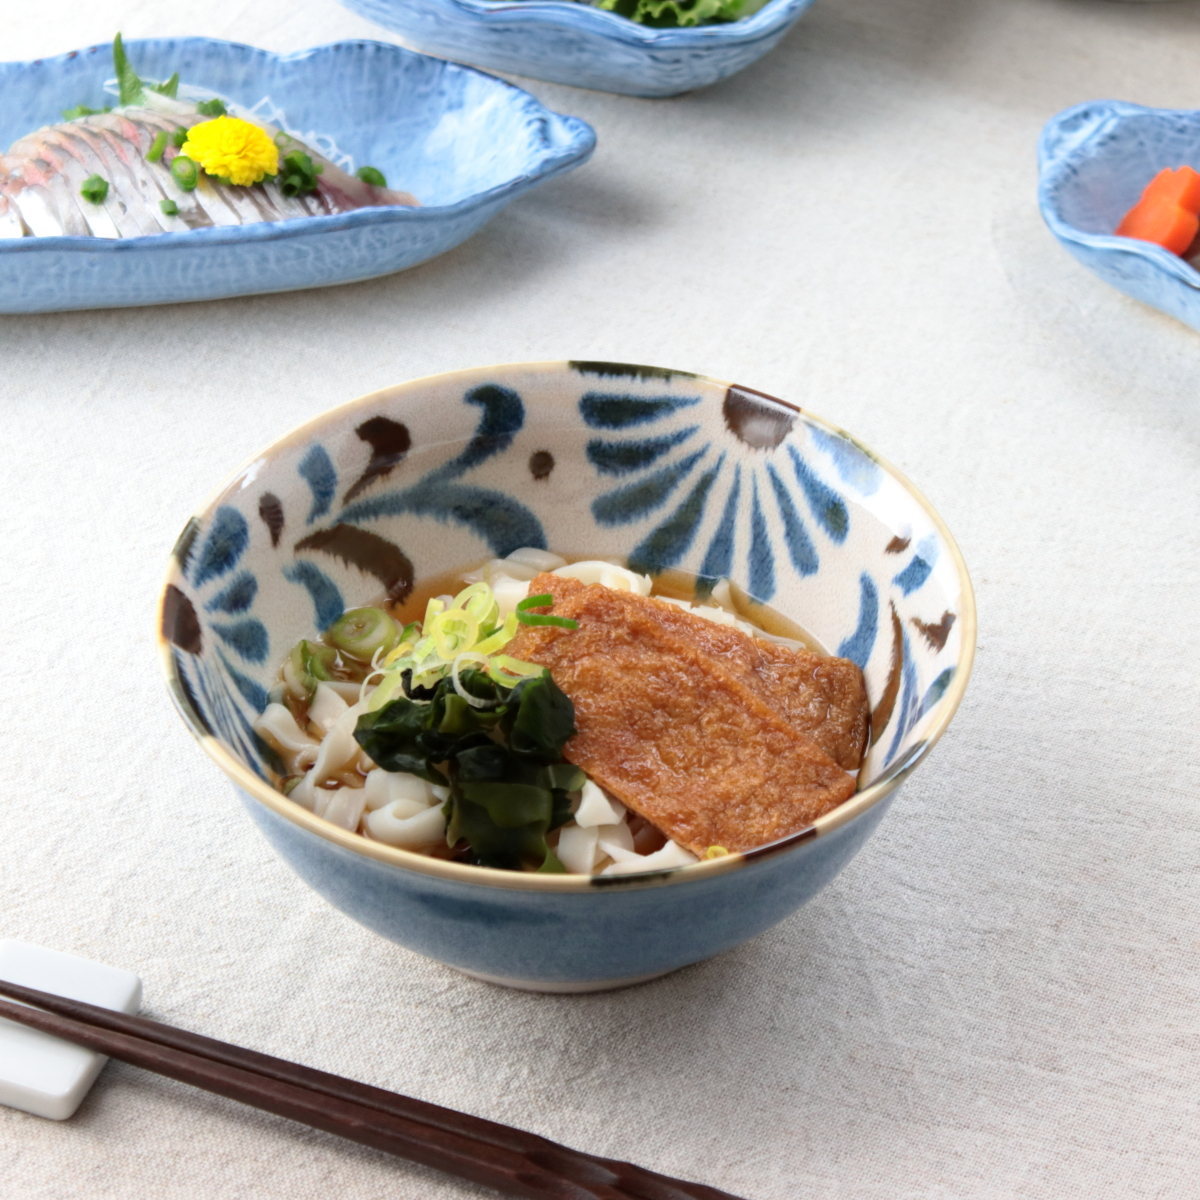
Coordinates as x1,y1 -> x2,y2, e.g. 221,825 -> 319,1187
0,0 -> 1200,1200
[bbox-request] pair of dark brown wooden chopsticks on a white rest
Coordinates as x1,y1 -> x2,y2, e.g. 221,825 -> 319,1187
0,979 -> 739,1200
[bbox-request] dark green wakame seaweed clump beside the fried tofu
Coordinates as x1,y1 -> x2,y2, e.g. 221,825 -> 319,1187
354,671 -> 584,871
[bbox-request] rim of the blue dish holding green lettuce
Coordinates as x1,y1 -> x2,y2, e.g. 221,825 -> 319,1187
379,0 -> 815,49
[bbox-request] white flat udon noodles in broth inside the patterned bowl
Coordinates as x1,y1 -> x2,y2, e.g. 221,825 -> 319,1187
256,548 -> 868,875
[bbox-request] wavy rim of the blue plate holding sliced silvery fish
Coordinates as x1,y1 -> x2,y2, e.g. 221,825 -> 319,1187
0,37 -> 596,254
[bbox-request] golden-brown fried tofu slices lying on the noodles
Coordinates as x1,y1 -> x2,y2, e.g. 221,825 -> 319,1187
505,574 -> 865,856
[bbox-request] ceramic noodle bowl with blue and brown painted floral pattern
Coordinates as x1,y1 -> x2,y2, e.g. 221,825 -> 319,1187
162,362 -> 976,991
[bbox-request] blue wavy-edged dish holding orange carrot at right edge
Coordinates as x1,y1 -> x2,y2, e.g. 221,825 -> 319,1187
1038,100 -> 1200,329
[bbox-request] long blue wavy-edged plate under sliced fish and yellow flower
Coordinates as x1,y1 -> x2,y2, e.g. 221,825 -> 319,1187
0,37 -> 595,313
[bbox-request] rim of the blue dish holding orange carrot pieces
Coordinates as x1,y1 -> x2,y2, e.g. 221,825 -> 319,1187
1038,100 -> 1200,290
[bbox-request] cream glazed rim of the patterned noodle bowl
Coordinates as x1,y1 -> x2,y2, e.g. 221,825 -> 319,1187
155,359 -> 978,894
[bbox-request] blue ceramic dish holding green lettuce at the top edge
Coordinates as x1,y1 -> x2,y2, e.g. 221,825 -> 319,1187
342,0 -> 812,96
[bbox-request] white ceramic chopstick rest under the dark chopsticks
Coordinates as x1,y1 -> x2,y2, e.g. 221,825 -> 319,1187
0,941 -> 142,1121
